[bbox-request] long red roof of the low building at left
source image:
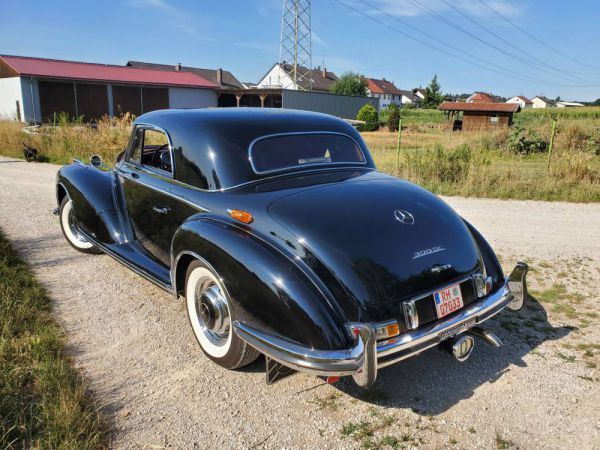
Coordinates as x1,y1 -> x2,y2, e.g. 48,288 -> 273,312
0,55 -> 218,88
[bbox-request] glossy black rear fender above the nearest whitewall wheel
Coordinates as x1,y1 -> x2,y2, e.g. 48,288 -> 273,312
171,218 -> 351,349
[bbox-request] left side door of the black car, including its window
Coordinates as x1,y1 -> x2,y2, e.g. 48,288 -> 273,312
118,125 -> 175,267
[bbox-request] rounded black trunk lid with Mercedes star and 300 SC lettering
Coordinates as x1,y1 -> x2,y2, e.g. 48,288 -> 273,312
269,174 -> 481,309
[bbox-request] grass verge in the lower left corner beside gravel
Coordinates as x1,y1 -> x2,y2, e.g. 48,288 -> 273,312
0,232 -> 107,449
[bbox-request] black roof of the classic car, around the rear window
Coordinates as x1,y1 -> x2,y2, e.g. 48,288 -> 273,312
135,108 -> 375,190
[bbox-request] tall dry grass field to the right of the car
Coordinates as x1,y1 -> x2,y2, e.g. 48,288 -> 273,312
363,119 -> 600,202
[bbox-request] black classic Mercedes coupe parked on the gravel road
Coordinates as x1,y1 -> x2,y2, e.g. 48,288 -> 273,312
55,108 -> 527,386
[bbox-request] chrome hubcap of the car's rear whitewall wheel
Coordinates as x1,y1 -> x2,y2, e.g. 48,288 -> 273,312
194,278 -> 231,346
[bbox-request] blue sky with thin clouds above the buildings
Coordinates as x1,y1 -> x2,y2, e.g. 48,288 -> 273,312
0,0 -> 600,100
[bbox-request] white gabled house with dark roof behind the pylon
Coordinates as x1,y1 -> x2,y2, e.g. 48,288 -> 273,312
257,63 -> 337,92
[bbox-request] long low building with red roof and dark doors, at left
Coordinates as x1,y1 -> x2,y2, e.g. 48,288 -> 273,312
0,55 -> 218,123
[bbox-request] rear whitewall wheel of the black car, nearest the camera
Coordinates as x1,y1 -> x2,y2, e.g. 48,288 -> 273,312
185,261 -> 259,369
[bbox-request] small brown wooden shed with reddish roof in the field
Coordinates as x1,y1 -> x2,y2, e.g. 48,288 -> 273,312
438,102 -> 521,130
